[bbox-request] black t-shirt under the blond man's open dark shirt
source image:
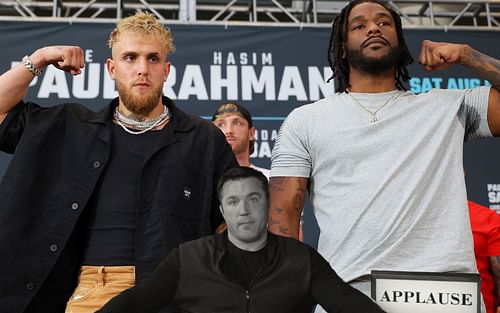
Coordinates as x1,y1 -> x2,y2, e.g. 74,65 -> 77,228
82,124 -> 161,266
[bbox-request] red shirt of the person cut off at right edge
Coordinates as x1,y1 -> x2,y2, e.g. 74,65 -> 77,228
469,201 -> 500,313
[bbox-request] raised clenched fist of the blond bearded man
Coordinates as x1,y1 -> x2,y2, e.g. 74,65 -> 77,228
30,46 -> 85,75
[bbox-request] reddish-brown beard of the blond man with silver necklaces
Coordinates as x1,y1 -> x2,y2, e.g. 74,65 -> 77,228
116,80 -> 162,116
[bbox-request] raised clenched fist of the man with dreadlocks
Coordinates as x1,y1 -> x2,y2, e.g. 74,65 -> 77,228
418,40 -> 470,71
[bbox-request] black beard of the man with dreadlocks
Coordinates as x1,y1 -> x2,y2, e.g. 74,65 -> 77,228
346,46 -> 402,75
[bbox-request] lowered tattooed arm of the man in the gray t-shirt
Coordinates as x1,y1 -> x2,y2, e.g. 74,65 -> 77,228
269,177 -> 308,239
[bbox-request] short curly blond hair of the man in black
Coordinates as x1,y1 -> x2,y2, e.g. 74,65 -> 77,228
108,12 -> 175,54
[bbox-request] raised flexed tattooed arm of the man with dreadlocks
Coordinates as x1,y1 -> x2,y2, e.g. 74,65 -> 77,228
419,40 -> 500,137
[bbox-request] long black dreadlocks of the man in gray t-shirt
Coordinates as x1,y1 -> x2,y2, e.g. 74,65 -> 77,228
328,0 -> 413,92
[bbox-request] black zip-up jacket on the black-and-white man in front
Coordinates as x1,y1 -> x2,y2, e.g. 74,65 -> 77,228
97,233 -> 384,313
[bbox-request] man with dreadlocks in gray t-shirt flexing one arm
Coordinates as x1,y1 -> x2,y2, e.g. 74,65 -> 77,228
269,0 -> 500,308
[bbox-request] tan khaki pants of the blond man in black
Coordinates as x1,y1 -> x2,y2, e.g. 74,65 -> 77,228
66,266 -> 135,313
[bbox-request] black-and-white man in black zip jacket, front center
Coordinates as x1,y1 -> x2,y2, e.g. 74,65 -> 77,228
97,167 -> 384,313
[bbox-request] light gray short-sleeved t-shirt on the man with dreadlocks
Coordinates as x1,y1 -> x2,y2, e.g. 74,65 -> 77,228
271,87 -> 491,282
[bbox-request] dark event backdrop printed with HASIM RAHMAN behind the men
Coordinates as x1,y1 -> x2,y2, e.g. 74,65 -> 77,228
0,22 -> 500,245
